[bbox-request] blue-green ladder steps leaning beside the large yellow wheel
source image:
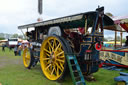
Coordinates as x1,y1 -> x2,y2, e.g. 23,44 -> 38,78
66,54 -> 86,85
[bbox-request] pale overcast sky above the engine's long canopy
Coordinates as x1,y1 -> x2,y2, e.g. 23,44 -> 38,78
0,0 -> 128,34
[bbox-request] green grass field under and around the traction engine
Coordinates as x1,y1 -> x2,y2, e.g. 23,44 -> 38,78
0,47 -> 128,85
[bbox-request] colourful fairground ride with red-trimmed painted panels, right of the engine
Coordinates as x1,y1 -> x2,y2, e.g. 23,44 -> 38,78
100,17 -> 128,68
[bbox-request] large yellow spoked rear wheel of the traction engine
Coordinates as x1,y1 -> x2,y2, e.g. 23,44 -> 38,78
40,36 -> 66,80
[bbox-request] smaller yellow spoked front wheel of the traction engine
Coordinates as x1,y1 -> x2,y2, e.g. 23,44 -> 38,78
23,48 -> 31,68
